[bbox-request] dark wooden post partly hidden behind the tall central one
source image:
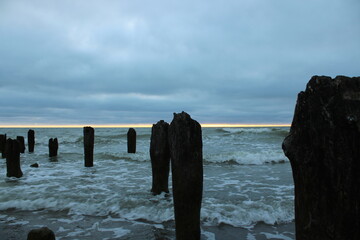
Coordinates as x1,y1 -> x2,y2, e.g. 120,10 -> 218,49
150,120 -> 170,195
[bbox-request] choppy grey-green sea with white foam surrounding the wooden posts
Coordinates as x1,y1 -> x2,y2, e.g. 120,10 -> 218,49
0,127 -> 295,240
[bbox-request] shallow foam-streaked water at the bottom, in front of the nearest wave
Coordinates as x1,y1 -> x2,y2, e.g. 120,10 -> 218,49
0,209 -> 295,240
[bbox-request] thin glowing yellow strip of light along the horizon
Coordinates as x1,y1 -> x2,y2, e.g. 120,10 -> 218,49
0,123 -> 291,128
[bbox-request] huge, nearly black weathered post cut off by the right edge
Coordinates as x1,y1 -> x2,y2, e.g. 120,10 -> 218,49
283,76 -> 360,240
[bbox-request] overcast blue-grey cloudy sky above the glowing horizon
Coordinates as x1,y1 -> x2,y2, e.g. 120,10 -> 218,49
0,0 -> 360,125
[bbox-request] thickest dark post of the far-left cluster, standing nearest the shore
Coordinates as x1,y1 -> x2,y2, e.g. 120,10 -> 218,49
6,138 -> 23,178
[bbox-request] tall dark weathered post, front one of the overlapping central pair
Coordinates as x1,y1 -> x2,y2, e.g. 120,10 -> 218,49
169,112 -> 203,240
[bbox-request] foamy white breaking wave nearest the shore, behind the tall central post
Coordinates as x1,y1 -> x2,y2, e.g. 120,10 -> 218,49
0,193 -> 294,228
